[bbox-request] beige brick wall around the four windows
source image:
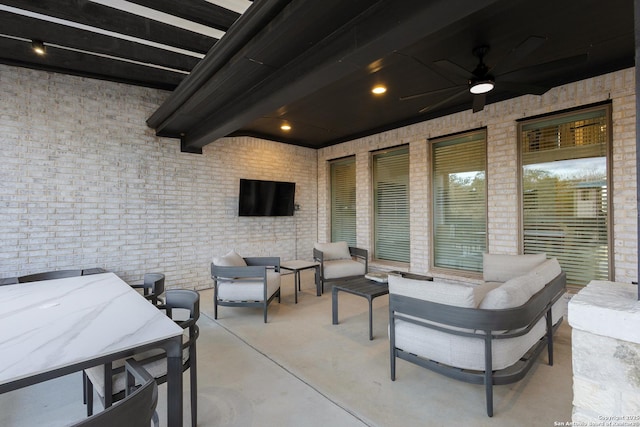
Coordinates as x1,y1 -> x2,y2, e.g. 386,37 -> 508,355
318,69 -> 637,282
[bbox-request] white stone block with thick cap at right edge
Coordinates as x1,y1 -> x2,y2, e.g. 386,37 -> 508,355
568,281 -> 640,425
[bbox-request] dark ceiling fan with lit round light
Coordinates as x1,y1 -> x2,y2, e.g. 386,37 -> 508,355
400,36 -> 587,113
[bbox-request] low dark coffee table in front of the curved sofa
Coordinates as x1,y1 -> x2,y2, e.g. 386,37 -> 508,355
331,271 -> 433,340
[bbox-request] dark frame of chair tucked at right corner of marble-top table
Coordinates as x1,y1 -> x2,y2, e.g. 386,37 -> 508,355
83,289 -> 200,427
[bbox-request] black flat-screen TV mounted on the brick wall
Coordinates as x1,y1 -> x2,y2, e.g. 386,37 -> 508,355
238,179 -> 296,216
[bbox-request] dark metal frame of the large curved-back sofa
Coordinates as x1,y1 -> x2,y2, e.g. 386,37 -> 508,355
389,272 -> 566,417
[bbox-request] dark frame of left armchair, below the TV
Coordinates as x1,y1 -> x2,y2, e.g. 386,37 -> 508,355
211,257 -> 280,323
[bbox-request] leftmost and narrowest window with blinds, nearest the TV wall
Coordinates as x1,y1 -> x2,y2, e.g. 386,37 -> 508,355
329,157 -> 356,246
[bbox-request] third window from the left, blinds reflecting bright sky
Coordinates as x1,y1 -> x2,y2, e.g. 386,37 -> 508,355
431,130 -> 487,272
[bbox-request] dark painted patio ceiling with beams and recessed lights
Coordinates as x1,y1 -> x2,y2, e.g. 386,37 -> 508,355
0,0 -> 635,152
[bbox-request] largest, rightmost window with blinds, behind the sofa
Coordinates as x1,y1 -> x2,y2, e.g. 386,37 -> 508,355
519,105 -> 611,285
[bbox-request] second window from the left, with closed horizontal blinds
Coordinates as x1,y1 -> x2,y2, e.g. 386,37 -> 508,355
372,147 -> 410,263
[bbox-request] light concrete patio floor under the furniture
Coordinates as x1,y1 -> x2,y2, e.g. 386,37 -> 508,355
0,272 -> 572,427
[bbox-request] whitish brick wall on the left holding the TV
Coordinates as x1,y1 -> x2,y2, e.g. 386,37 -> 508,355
0,65 -> 317,288
